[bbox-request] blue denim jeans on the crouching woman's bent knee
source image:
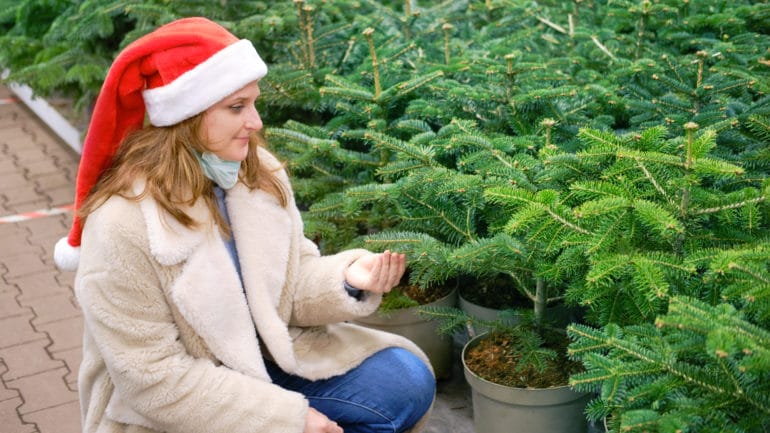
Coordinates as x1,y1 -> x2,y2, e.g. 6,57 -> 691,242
266,347 -> 436,433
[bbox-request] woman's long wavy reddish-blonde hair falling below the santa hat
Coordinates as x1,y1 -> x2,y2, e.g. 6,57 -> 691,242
78,113 -> 288,236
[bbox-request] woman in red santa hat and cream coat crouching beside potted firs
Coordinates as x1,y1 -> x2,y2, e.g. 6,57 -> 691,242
55,18 -> 435,433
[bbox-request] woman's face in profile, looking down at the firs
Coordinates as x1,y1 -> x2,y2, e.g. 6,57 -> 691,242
201,81 -> 262,161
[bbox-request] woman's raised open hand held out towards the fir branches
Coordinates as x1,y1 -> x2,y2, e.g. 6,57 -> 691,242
345,251 -> 406,293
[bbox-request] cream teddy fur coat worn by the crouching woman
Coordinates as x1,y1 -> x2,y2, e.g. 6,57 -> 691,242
75,149 -> 430,433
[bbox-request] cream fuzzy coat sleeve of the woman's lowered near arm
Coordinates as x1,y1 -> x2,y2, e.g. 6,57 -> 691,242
75,202 -> 307,433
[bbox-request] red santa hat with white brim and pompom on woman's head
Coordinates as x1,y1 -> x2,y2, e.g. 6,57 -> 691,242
54,17 -> 267,270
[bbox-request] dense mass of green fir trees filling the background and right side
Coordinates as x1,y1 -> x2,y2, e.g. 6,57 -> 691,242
0,0 -> 770,432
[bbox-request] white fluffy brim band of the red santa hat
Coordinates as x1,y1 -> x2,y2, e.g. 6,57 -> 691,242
142,39 -> 267,126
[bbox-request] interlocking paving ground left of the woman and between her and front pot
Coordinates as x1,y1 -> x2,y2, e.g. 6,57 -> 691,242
0,84 -> 473,433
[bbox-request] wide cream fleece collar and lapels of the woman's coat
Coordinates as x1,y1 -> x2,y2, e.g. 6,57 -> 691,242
137,177 -> 301,378
